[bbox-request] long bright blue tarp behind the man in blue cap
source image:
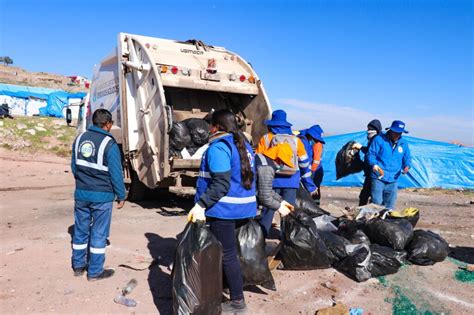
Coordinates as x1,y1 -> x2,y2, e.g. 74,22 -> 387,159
322,131 -> 474,189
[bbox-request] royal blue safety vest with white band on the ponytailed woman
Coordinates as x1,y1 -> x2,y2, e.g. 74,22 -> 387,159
195,135 -> 257,219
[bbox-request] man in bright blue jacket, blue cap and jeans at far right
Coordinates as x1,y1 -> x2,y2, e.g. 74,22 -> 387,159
367,120 -> 411,209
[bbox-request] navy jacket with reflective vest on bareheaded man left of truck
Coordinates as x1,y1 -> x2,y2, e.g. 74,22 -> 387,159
71,126 -> 125,202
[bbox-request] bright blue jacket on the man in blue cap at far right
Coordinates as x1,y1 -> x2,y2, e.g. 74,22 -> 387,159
367,134 -> 411,183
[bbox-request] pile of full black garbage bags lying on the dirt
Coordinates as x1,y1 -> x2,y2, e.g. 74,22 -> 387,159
279,189 -> 449,282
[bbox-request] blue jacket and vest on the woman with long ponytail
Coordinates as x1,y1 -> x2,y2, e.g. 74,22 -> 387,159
194,134 -> 257,219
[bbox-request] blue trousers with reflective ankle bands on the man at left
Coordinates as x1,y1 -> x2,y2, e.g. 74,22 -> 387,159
72,200 -> 113,277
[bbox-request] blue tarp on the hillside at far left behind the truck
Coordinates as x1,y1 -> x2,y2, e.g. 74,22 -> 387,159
0,84 -> 86,117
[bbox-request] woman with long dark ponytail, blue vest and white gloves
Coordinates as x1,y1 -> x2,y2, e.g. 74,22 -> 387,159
188,110 -> 257,313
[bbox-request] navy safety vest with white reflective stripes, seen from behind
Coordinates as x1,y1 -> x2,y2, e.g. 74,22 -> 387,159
74,129 -> 115,193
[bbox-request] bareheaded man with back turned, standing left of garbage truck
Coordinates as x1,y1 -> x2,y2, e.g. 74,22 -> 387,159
71,109 -> 125,281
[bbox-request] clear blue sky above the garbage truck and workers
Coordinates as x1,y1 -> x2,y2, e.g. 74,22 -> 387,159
0,0 -> 474,145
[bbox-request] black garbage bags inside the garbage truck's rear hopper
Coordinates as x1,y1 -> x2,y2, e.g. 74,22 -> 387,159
169,118 -> 210,158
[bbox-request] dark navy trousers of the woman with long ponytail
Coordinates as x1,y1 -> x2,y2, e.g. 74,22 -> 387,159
208,218 -> 244,301
